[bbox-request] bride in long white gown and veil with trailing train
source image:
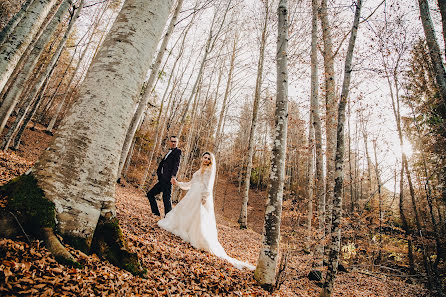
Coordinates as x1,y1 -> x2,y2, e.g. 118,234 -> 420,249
158,152 -> 255,270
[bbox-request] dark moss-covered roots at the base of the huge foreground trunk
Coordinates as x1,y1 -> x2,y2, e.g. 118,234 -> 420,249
0,174 -> 146,276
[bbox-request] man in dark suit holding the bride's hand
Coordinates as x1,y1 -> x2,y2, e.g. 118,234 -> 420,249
147,136 -> 181,216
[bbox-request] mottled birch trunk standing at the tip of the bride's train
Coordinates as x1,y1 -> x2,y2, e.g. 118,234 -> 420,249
254,0 -> 289,289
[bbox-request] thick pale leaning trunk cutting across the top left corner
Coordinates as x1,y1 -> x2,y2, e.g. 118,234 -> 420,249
0,0 -> 57,90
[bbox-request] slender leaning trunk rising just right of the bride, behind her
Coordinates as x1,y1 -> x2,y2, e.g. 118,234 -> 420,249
240,0 -> 269,229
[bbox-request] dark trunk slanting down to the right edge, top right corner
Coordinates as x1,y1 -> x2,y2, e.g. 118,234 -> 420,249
418,0 -> 446,104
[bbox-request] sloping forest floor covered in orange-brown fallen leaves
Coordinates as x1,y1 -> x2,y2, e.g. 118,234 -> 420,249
0,121 -> 429,297
